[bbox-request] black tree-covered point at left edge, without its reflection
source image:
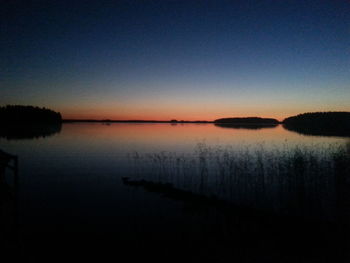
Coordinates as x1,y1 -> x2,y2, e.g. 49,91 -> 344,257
0,105 -> 62,123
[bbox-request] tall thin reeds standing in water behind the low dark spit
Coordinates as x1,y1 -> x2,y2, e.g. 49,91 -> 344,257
129,143 -> 350,222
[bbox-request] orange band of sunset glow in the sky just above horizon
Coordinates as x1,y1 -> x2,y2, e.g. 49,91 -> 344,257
60,104 -> 348,121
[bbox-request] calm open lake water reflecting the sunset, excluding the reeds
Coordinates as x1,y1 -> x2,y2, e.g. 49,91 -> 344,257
0,123 -> 349,262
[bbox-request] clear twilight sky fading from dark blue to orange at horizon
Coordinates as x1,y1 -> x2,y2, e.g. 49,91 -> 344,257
0,0 -> 350,120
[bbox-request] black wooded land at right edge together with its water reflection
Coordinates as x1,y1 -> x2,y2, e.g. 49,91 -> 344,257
283,112 -> 350,136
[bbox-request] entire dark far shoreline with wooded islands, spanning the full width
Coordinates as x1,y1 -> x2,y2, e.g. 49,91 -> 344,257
0,105 -> 350,138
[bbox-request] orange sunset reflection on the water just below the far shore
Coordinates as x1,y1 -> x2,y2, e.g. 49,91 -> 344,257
59,123 -> 345,155
